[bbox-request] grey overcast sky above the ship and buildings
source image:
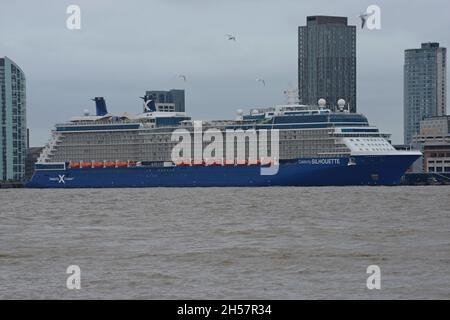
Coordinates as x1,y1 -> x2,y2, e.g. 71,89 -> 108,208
0,0 -> 450,146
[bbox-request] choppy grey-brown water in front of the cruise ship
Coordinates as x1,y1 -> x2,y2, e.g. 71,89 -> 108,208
0,186 -> 450,299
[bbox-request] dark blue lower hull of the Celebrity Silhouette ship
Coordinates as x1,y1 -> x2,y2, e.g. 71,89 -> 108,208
26,154 -> 419,188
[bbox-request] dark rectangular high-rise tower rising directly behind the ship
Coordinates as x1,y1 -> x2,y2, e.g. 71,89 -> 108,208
298,16 -> 356,112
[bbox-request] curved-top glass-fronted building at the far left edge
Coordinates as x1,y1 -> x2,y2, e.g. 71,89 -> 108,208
0,57 -> 27,181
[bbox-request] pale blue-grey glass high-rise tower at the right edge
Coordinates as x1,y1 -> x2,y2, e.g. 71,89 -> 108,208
403,42 -> 447,144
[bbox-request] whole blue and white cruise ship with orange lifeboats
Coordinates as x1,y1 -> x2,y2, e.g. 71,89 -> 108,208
27,93 -> 421,188
